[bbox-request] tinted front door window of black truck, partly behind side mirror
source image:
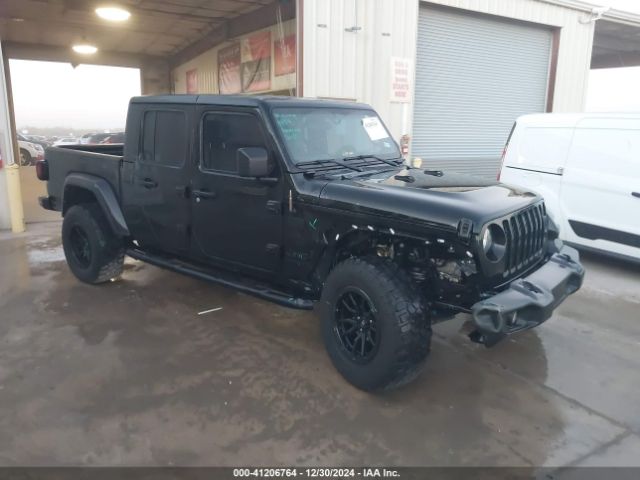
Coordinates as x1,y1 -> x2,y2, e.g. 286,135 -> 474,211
202,113 -> 266,173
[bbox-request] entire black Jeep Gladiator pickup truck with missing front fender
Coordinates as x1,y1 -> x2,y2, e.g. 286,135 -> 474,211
37,95 -> 584,390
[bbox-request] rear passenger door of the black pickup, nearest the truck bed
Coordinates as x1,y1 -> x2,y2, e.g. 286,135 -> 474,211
125,105 -> 195,254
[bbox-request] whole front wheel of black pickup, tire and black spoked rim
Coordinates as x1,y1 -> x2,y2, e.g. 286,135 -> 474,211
320,257 -> 431,391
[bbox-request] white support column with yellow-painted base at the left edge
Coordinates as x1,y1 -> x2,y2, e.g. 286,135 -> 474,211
0,42 -> 25,233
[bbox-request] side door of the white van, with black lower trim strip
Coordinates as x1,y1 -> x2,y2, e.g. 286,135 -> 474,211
562,119 -> 640,256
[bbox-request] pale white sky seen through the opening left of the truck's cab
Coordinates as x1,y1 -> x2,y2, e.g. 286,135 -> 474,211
10,60 -> 140,129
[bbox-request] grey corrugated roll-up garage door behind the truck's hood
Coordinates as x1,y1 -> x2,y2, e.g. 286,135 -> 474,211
412,4 -> 552,176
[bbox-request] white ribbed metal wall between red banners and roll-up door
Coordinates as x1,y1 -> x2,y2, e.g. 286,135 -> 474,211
303,0 -> 418,140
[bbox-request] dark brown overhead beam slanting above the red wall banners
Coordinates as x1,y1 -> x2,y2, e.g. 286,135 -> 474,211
169,0 -> 296,68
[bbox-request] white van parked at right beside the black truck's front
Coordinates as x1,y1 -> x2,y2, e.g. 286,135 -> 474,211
500,113 -> 640,260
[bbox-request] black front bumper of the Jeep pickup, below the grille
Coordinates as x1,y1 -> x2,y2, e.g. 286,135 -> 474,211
469,246 -> 584,347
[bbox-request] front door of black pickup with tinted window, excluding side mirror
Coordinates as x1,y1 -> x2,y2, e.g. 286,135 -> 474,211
191,106 -> 283,274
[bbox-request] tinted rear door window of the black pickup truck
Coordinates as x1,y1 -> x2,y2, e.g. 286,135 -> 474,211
141,110 -> 188,167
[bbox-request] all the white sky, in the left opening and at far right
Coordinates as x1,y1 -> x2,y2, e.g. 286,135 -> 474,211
10,0 -> 640,129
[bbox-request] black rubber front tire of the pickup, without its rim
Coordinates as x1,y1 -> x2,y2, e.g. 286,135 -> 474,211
320,257 -> 431,391
